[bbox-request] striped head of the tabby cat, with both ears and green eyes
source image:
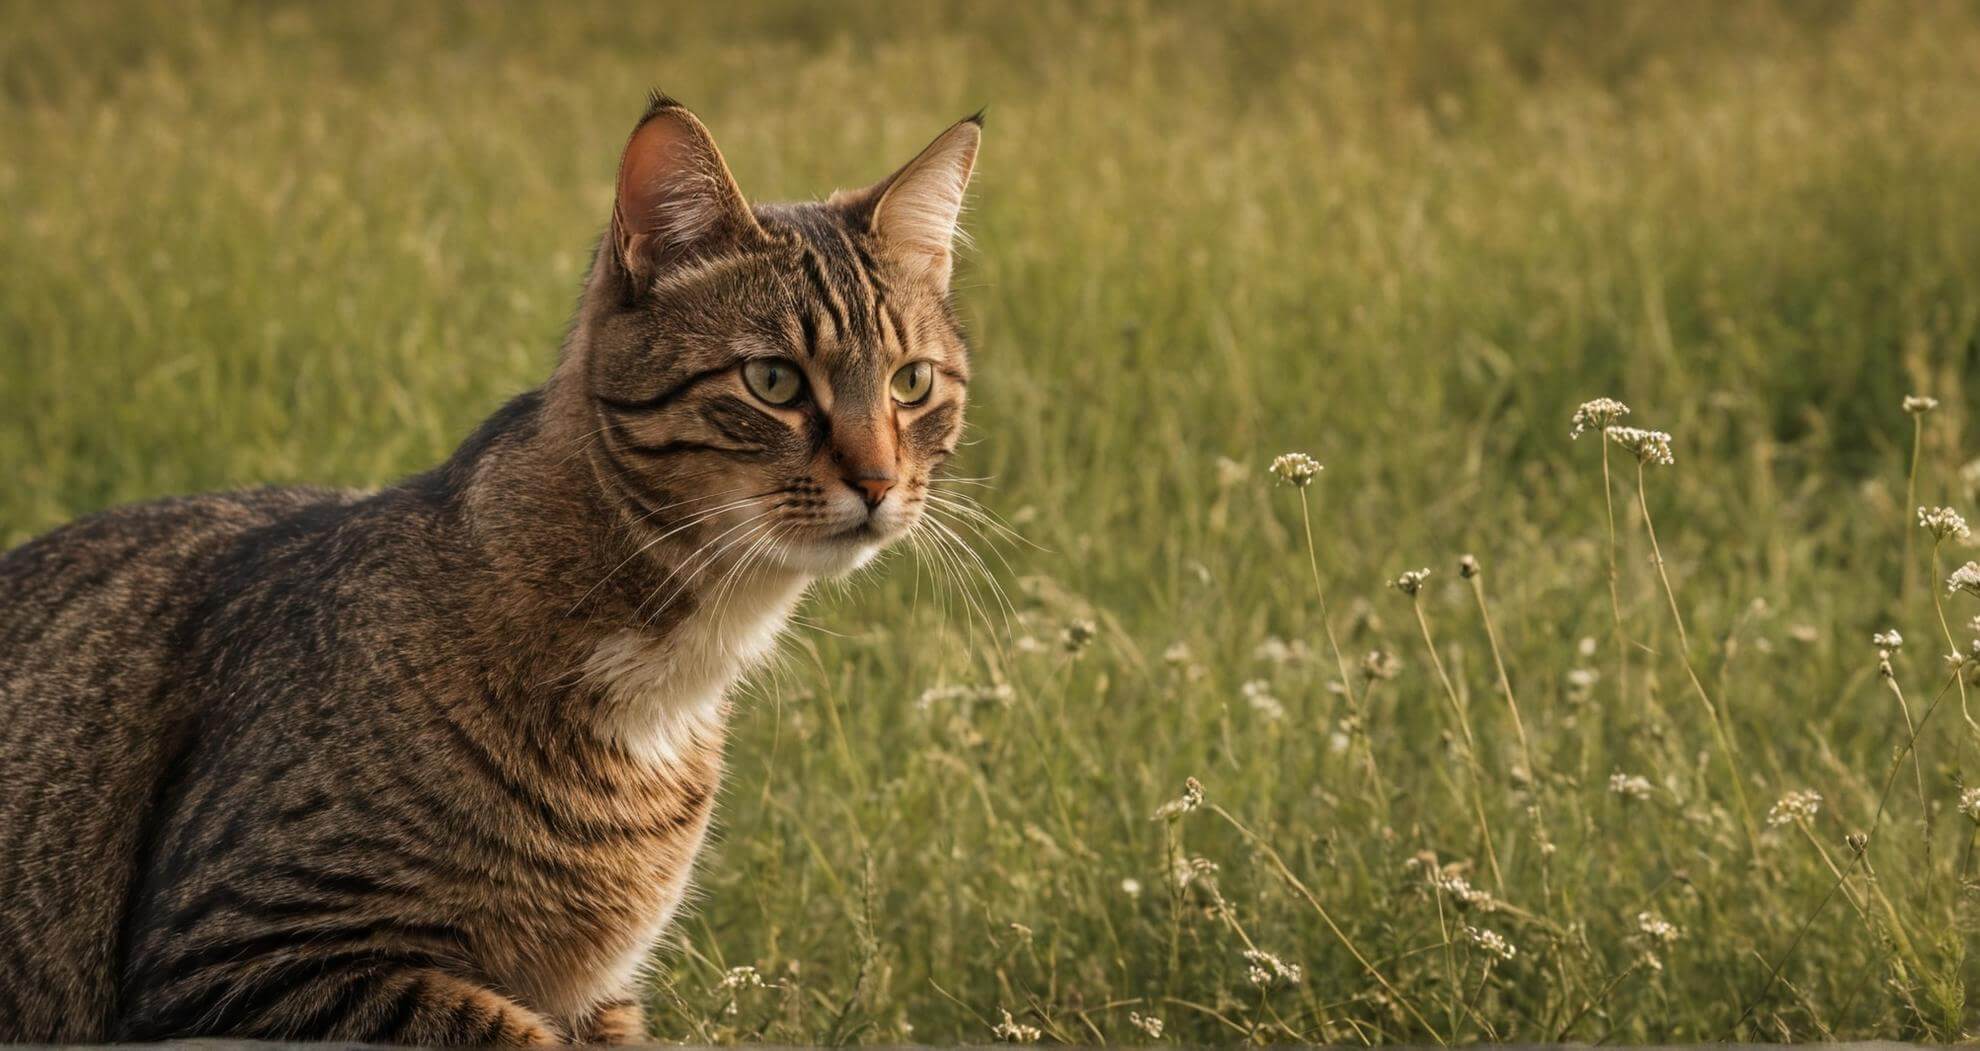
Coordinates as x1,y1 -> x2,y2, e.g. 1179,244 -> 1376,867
566,99 -> 980,576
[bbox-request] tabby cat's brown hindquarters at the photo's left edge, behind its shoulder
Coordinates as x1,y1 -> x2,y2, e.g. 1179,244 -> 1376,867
0,489 -> 352,1041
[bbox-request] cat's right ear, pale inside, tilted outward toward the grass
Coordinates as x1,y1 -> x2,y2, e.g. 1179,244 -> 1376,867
840,113 -> 984,289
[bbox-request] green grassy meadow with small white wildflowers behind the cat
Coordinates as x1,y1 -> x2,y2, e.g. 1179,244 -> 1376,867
0,0 -> 1980,1043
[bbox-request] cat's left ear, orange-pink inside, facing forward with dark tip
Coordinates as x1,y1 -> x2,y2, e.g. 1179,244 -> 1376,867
612,95 -> 764,293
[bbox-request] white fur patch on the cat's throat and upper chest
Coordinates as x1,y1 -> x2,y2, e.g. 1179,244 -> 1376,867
584,574 -> 804,764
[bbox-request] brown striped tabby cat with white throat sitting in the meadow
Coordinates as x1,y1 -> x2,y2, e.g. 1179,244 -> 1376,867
0,97 -> 980,1045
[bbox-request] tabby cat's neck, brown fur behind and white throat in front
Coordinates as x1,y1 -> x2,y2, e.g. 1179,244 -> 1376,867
422,394 -> 810,764
